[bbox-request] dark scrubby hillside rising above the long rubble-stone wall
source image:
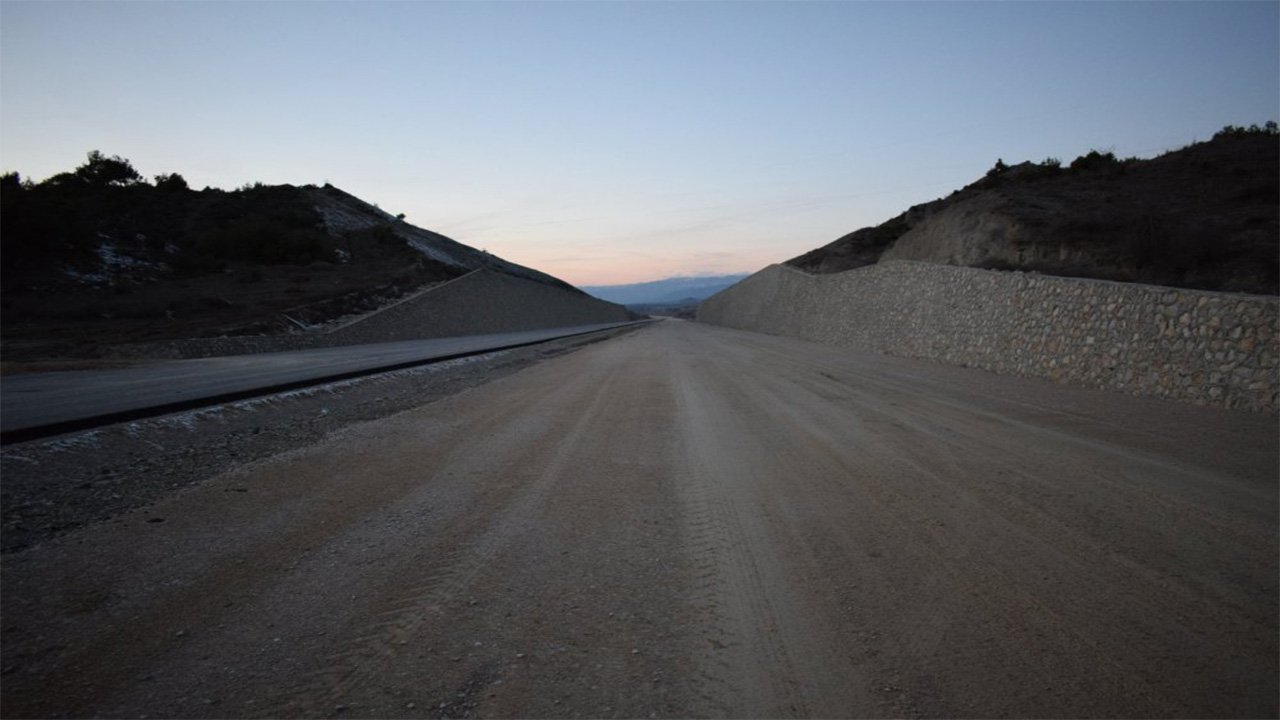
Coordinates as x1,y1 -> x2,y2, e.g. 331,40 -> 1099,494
787,123 -> 1280,295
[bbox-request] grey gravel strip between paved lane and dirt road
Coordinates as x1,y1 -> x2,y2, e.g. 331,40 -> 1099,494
0,322 -> 640,552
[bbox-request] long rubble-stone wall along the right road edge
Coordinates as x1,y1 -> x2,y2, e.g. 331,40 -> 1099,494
698,260 -> 1280,413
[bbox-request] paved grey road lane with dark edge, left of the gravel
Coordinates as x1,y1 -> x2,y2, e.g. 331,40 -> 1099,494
0,317 -> 650,442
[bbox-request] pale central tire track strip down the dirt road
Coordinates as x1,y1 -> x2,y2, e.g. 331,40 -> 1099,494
672,338 -> 867,717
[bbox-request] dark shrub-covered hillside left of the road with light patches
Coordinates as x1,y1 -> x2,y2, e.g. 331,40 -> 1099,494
0,152 -> 577,360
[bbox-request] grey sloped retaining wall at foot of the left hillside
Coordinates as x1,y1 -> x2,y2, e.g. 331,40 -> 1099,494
115,269 -> 628,357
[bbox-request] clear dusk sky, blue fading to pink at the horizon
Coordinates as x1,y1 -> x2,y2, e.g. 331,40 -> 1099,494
0,0 -> 1280,284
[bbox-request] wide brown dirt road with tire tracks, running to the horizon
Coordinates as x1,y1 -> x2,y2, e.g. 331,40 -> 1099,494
3,322 -> 1280,717
